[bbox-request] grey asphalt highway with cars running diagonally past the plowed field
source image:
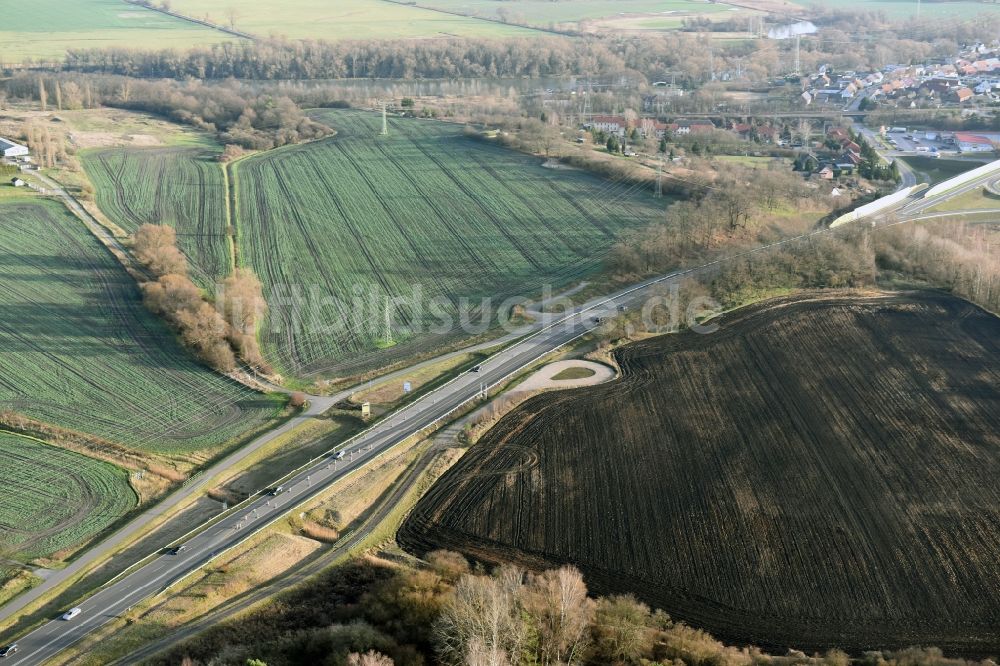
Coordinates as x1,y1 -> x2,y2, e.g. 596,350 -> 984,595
4,158 -> 995,666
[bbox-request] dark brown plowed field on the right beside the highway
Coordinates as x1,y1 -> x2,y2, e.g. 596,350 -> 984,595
399,293 -> 1000,656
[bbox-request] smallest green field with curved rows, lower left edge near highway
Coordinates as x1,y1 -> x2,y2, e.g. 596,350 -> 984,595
0,432 -> 138,560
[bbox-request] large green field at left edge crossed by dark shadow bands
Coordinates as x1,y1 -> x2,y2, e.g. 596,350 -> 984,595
0,199 -> 280,461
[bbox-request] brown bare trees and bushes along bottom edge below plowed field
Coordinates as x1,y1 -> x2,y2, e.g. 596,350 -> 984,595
149,551 -> 990,666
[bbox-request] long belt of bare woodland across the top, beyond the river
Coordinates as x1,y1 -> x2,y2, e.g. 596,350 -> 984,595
27,8 -> 1000,89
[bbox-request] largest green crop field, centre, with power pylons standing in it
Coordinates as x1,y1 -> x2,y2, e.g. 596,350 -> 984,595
235,111 -> 663,376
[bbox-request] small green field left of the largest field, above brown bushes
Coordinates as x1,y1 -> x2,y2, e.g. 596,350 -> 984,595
83,148 -> 230,287
